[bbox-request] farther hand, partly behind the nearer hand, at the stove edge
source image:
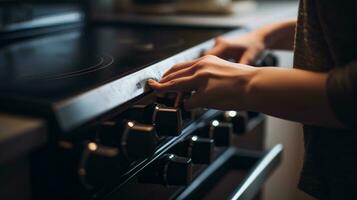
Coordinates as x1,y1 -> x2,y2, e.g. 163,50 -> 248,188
205,32 -> 266,65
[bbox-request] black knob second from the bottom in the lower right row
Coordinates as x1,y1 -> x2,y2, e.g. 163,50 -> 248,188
173,135 -> 214,164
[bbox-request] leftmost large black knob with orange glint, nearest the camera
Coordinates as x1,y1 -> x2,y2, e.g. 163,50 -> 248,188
78,142 -> 121,189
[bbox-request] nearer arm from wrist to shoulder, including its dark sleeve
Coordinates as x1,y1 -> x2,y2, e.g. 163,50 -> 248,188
247,61 -> 357,128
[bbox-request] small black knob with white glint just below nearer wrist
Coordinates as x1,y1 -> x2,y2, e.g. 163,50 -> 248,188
222,111 -> 248,135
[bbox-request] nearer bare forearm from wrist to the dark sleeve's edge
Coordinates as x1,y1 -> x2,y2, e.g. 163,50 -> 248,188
247,67 -> 342,127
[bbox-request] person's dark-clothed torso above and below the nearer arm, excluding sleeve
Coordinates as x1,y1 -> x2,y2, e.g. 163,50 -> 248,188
294,0 -> 357,199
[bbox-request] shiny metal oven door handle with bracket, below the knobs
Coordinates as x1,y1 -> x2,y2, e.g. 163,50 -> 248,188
176,144 -> 283,200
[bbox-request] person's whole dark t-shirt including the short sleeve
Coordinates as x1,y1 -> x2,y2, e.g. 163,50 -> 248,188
294,0 -> 357,199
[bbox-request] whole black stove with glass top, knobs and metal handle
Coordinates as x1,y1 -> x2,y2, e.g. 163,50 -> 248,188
0,24 -> 282,199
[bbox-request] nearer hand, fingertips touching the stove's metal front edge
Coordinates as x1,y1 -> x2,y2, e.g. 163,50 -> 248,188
148,56 -> 257,110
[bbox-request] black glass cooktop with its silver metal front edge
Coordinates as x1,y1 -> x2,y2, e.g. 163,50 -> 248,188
0,26 -> 243,131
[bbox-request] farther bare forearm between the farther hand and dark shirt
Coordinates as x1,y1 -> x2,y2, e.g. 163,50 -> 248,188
255,19 -> 296,50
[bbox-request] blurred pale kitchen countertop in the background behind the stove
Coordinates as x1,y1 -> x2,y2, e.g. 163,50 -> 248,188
94,1 -> 298,29
